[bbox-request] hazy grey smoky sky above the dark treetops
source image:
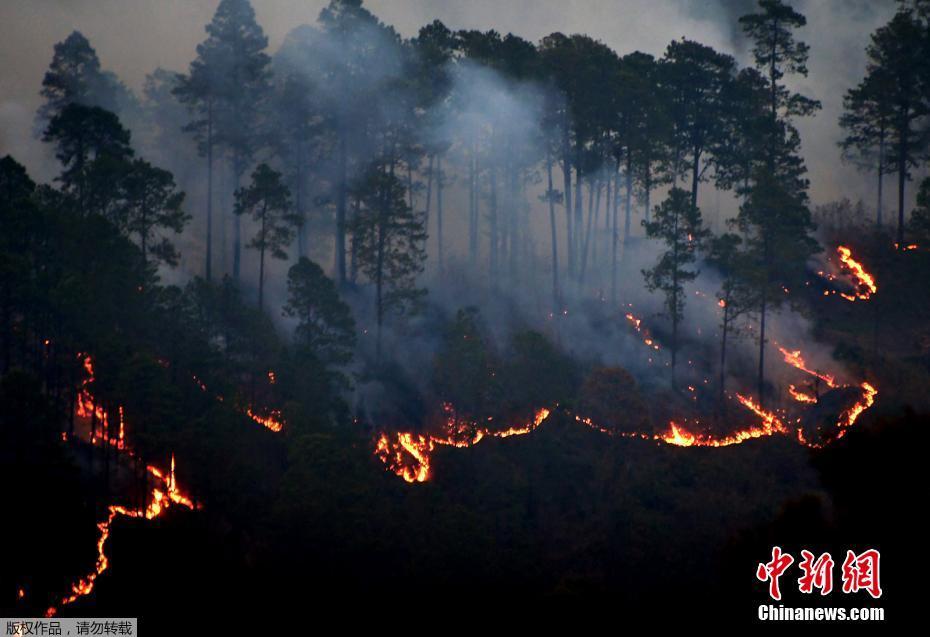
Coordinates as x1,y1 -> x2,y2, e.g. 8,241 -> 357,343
0,0 -> 895,204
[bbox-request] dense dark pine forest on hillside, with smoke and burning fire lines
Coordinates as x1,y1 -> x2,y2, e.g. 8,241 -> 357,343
0,0 -> 930,626
